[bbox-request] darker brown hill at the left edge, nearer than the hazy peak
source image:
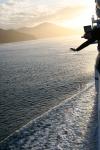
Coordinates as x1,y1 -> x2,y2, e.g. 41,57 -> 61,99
0,29 -> 36,43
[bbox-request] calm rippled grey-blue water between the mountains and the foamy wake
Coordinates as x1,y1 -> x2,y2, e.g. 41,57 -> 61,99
0,37 -> 97,140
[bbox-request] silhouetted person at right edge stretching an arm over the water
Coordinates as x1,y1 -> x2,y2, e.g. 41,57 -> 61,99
71,27 -> 100,94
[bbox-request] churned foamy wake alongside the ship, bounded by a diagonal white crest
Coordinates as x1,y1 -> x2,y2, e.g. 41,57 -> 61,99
0,83 -> 97,150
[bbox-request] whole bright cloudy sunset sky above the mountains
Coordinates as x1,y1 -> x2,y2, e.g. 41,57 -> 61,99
0,0 -> 95,29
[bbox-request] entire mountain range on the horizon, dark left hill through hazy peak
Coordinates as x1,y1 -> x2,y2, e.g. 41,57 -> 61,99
0,22 -> 80,43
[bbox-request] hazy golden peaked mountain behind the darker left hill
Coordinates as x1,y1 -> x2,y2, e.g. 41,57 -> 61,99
18,22 -> 79,38
